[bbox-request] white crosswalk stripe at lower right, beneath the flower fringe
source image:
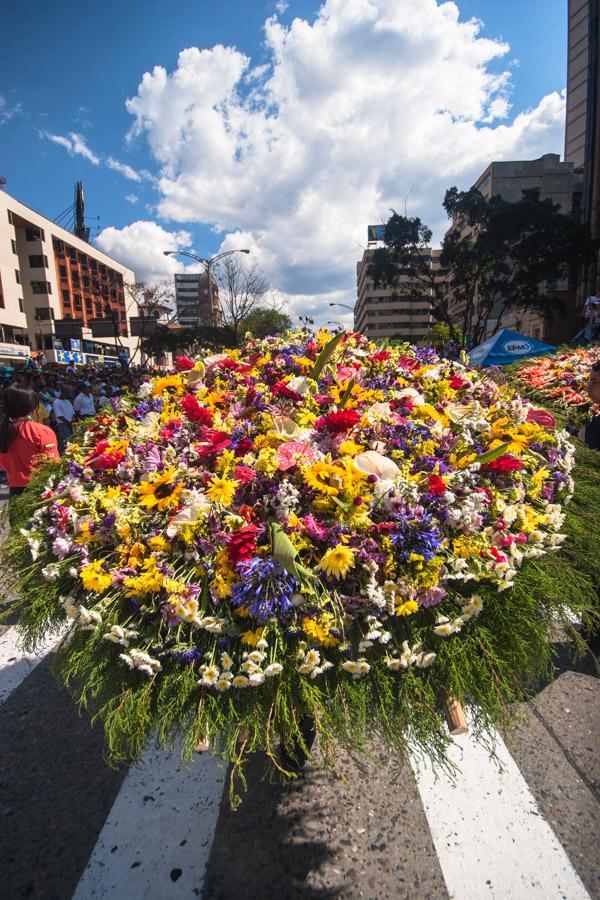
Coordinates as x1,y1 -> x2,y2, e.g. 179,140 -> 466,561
413,734 -> 590,900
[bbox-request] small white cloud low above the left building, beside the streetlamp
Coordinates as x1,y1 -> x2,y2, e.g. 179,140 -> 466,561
96,221 -> 191,282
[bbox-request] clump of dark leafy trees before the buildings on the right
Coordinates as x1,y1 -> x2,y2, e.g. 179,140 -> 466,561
370,187 -> 592,346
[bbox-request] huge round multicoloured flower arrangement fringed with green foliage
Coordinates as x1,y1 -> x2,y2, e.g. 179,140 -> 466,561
9,332 -> 596,796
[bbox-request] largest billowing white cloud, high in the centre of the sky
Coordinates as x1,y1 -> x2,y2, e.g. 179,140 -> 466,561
116,0 -> 565,319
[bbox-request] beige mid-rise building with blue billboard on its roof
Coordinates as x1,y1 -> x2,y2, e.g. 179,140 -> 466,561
354,241 -> 439,343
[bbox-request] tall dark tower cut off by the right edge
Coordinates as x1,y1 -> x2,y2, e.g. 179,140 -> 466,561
565,0 -> 600,302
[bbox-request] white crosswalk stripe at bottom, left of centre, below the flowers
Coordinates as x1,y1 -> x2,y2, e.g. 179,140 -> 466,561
73,747 -> 226,900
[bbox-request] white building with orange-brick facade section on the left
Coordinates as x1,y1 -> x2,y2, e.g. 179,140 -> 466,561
0,190 -> 137,364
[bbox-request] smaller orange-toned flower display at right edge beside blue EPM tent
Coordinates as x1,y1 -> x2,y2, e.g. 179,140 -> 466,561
516,347 -> 600,419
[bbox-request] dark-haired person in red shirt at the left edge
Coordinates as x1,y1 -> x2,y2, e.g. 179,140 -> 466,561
0,385 -> 60,512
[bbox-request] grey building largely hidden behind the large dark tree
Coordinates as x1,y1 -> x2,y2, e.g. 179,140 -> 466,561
449,153 -> 582,344
